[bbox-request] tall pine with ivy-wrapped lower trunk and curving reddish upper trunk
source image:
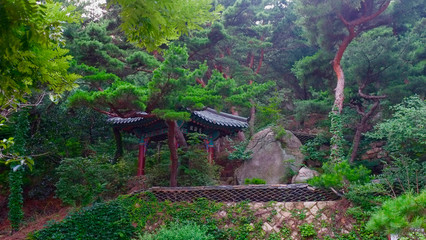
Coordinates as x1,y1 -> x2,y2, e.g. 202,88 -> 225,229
297,0 -> 391,161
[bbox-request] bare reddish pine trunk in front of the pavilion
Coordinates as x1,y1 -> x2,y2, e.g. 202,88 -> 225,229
166,120 -> 178,187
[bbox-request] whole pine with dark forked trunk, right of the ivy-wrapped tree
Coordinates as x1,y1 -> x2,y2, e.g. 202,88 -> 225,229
343,20 -> 426,161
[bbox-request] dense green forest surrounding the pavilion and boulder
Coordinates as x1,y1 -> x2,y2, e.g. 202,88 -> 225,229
0,0 -> 426,238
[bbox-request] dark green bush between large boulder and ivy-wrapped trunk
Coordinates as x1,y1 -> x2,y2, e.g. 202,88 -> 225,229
300,133 -> 330,162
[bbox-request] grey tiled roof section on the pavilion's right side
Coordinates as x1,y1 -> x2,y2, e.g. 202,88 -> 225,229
193,108 -> 248,128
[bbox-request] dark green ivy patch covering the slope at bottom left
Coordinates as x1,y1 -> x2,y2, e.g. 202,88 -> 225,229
28,199 -> 135,240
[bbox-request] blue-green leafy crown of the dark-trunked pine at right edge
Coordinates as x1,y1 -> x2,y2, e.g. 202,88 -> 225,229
342,24 -> 426,106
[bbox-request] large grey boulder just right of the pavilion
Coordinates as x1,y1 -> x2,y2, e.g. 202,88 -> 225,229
235,128 -> 303,184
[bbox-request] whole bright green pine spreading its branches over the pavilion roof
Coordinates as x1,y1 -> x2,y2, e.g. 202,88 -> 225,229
70,45 -> 220,186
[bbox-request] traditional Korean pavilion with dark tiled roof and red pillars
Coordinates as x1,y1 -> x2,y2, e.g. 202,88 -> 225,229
107,108 -> 248,176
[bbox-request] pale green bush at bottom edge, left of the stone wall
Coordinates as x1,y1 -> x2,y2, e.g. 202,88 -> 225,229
139,222 -> 214,240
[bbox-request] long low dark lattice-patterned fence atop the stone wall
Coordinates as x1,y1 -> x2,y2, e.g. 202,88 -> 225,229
141,184 -> 339,202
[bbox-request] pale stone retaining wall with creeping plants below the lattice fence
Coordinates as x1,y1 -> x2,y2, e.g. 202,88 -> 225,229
218,200 -> 354,240
